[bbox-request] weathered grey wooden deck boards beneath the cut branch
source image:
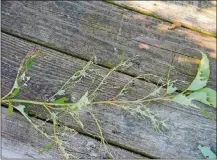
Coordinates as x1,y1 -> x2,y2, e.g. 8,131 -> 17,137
1,1 -> 216,159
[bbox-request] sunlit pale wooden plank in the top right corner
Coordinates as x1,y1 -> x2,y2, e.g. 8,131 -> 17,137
110,1 -> 216,37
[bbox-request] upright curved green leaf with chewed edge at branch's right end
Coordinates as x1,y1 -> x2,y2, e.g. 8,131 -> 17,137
187,52 -> 210,91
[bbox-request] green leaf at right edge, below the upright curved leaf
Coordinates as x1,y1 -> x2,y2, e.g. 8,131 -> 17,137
196,88 -> 216,108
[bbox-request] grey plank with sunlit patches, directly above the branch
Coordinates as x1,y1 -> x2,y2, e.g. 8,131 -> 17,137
2,1 -> 216,89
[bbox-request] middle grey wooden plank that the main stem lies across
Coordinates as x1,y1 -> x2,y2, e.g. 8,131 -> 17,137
1,34 -> 216,158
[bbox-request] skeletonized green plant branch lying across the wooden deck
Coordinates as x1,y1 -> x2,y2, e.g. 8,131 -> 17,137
1,50 -> 216,159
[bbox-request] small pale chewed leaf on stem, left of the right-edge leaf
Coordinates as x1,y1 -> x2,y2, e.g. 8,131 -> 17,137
172,94 -> 198,108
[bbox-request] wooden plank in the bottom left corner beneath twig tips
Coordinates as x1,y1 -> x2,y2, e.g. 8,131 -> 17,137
1,107 -> 146,159
